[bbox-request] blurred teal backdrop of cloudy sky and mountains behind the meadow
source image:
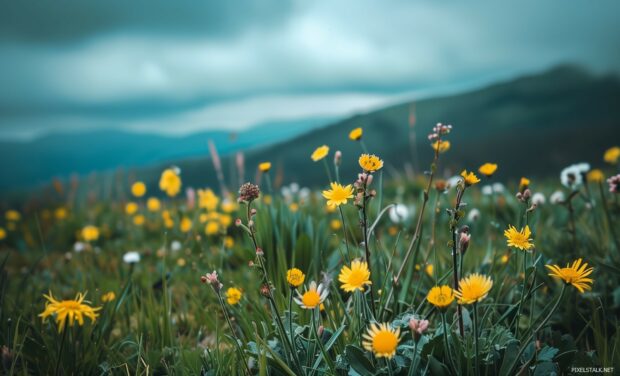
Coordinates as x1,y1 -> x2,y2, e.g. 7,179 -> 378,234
0,0 -> 620,201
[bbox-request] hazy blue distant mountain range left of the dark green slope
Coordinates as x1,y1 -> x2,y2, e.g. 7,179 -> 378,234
0,118 -> 331,190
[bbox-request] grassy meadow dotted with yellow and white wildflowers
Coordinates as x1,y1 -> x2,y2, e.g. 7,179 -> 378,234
0,124 -> 620,376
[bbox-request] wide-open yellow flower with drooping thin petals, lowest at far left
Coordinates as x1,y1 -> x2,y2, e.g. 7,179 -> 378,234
39,292 -> 101,332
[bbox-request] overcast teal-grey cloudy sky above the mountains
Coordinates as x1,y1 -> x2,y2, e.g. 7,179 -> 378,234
0,0 -> 620,139
